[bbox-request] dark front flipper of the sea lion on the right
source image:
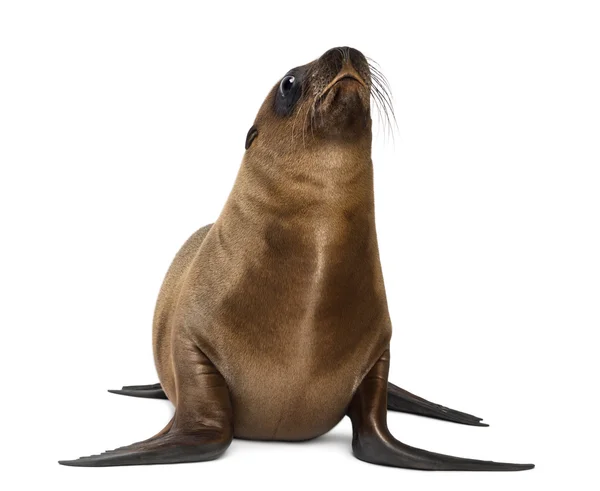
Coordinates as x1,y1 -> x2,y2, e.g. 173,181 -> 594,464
348,350 -> 534,471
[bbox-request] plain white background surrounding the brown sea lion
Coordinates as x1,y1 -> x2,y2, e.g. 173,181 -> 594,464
0,0 -> 600,491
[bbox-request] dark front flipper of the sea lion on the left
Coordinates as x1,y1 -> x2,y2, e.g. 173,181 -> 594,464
59,341 -> 233,467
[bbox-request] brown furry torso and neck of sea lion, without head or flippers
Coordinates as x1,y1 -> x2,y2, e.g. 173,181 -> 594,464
154,142 -> 391,440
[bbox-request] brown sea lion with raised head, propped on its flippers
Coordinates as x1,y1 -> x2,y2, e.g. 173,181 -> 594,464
60,47 -> 533,471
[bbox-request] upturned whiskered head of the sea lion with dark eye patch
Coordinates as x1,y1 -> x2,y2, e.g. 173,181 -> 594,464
246,47 -> 389,149
